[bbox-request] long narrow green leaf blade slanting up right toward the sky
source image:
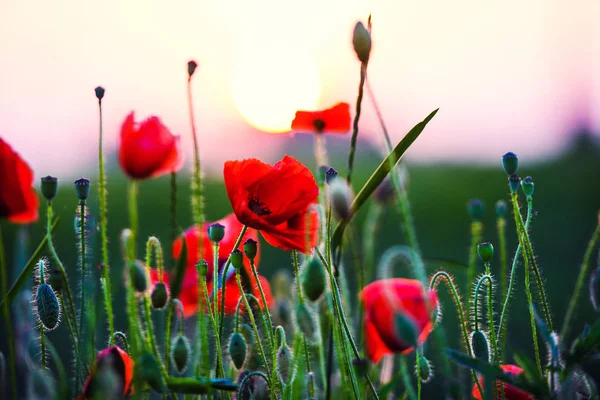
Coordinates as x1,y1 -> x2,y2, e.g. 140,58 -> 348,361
331,108 -> 439,260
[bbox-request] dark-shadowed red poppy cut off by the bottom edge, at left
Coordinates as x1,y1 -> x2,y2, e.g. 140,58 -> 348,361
79,346 -> 135,400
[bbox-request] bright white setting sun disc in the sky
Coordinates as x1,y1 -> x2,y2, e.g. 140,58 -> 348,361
232,45 -> 321,133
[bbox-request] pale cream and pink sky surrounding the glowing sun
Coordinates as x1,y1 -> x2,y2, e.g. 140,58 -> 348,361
0,0 -> 600,177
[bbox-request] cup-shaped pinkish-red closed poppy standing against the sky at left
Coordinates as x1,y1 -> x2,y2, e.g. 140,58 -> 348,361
119,111 -> 183,179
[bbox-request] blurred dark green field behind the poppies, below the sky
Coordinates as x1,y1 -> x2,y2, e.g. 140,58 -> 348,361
0,136 -> 600,396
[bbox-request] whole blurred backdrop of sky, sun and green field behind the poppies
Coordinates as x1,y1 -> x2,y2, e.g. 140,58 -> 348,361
0,0 -> 600,396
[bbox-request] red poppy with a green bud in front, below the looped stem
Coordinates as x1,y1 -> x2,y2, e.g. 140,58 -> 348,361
360,278 -> 437,363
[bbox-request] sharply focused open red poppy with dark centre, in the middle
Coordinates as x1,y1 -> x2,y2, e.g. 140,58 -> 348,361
224,155 -> 319,252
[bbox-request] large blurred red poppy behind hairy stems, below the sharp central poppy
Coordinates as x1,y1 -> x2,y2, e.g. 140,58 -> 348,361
150,214 -> 273,318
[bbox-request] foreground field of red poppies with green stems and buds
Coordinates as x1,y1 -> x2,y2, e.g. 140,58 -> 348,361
0,17 -> 600,400
